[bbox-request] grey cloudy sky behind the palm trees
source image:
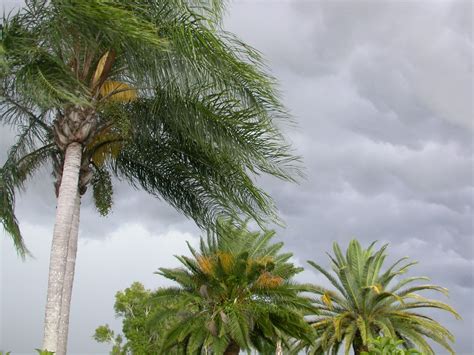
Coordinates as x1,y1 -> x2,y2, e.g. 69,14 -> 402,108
0,0 -> 474,354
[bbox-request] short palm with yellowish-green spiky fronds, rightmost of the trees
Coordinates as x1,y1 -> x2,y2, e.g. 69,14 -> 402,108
300,240 -> 460,355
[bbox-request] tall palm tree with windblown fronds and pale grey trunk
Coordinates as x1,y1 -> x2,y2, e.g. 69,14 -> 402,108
0,0 -> 298,354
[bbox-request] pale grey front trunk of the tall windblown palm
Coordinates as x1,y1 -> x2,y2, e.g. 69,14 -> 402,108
43,142 -> 82,352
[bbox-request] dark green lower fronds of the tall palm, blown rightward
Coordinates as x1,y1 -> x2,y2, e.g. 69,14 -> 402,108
106,82 -> 295,226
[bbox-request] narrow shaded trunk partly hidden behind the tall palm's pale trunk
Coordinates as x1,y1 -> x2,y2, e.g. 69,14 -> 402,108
56,193 -> 81,355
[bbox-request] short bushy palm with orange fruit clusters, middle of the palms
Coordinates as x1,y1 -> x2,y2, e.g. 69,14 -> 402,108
152,220 -> 314,355
